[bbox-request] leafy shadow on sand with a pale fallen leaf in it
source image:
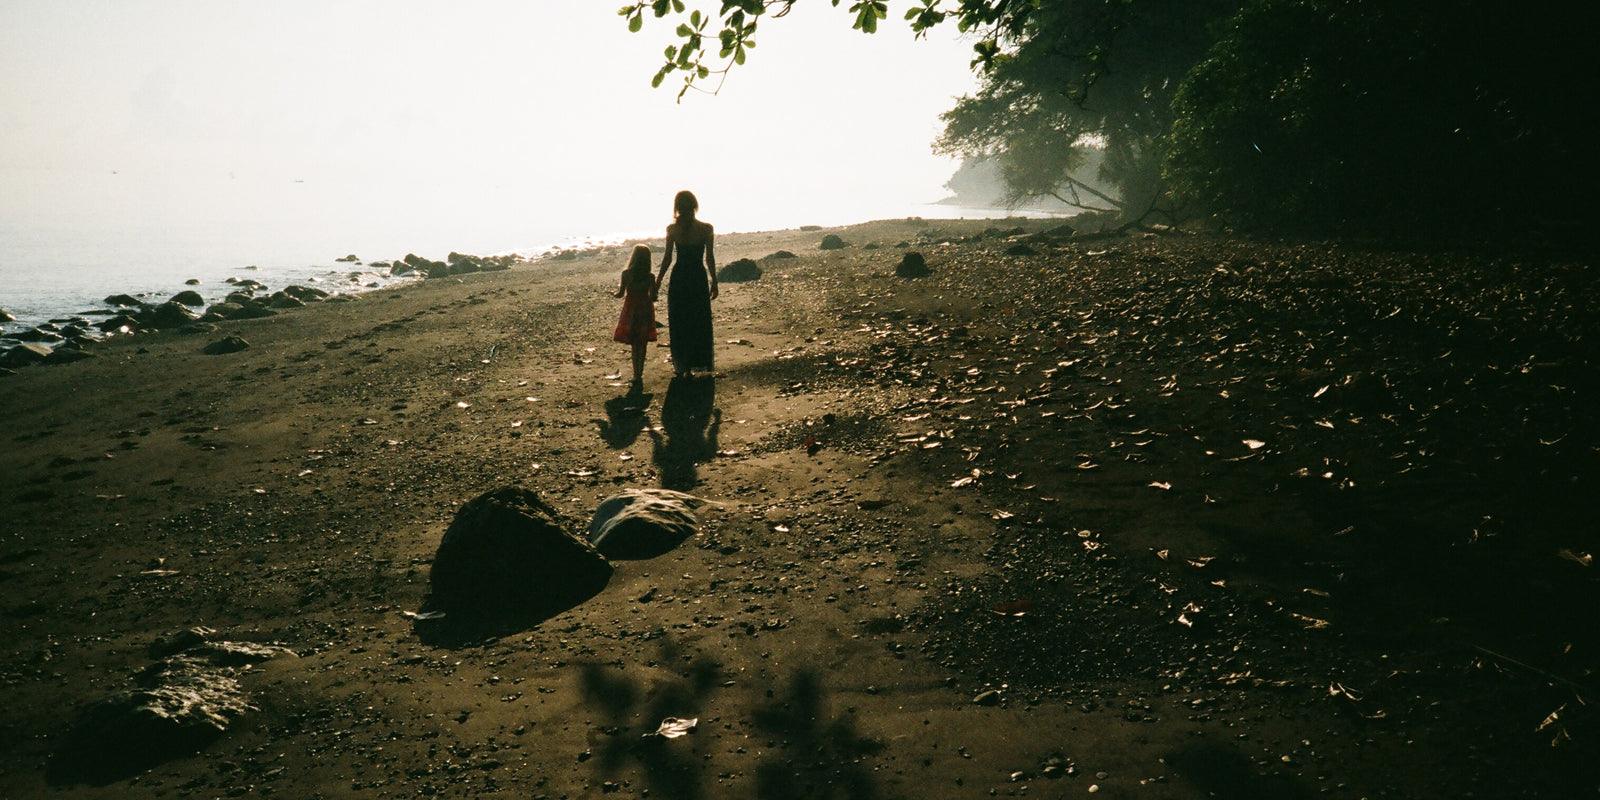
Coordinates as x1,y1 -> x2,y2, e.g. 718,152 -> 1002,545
579,640 -> 720,800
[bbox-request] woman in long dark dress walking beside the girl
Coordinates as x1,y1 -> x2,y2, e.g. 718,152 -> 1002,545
656,190 -> 717,378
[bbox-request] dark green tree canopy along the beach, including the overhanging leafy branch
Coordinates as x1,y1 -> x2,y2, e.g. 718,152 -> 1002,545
619,0 -> 1600,229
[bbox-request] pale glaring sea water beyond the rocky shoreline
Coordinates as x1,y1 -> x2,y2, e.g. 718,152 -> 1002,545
0,203 -> 1050,333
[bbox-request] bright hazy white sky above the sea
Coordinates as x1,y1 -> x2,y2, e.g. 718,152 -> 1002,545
0,0 -> 974,254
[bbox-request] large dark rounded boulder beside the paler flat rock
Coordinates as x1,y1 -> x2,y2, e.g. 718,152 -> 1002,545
429,486 -> 611,616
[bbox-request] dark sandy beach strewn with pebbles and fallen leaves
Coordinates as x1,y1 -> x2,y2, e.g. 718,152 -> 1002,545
0,222 -> 1600,798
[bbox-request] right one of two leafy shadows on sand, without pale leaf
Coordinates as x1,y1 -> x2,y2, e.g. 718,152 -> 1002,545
755,669 -> 883,800
